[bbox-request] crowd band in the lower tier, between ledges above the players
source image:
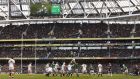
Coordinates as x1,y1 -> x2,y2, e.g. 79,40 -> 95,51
0,48 -> 140,58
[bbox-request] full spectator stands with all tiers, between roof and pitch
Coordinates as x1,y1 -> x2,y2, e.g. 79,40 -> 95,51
0,23 -> 140,73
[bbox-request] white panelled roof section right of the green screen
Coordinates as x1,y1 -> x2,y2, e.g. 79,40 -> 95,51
60,0 -> 140,18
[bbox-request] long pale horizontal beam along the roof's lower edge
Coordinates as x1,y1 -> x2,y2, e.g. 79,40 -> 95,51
0,14 -> 140,24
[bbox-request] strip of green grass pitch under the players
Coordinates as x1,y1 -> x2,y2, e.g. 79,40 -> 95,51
0,74 -> 140,79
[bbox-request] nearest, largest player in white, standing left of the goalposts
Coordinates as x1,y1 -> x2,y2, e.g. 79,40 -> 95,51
8,57 -> 15,79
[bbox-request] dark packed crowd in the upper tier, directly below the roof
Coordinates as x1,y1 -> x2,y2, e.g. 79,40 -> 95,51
0,23 -> 140,39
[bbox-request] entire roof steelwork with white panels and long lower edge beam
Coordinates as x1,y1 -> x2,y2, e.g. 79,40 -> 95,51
0,0 -> 140,23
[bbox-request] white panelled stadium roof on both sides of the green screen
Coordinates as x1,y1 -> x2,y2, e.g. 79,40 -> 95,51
0,0 -> 140,20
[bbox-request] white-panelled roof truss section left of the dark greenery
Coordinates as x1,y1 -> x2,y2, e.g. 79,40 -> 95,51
0,0 -> 30,20
